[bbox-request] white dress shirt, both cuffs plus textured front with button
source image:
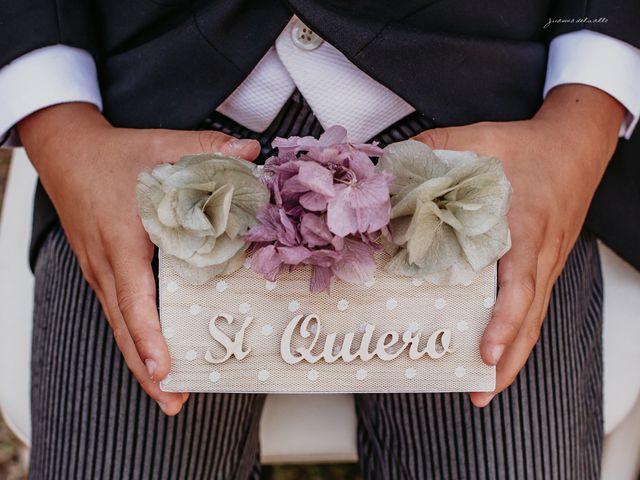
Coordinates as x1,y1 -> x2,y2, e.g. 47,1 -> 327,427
0,17 -> 640,146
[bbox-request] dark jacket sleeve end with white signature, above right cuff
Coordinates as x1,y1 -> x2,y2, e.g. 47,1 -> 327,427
548,0 -> 640,48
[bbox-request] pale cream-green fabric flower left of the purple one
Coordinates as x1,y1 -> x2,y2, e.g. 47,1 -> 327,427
136,154 -> 269,284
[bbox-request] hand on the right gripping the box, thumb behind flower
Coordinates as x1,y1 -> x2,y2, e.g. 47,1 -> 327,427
415,85 -> 624,407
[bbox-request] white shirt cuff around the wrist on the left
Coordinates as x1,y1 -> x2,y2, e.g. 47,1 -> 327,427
0,45 -> 102,147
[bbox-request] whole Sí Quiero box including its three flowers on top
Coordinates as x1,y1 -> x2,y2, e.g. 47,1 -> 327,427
137,127 -> 511,393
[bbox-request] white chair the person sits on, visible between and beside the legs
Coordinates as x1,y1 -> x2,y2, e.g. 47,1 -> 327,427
0,150 -> 640,480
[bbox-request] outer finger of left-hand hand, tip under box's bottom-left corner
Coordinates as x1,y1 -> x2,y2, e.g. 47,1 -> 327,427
96,260 -> 188,415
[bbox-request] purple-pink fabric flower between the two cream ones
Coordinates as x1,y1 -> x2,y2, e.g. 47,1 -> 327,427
245,126 -> 392,292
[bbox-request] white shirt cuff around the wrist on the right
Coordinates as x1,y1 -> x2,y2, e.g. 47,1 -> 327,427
544,30 -> 640,139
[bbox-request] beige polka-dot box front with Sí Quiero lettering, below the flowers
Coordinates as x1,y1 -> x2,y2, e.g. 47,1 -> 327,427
159,252 -> 496,393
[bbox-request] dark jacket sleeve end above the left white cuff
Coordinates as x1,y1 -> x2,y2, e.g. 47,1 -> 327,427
0,0 -> 97,67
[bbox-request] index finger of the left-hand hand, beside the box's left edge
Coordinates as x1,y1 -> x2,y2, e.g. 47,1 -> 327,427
107,237 -> 171,380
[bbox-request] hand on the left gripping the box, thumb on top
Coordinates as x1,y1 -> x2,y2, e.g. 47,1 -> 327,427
18,103 -> 260,415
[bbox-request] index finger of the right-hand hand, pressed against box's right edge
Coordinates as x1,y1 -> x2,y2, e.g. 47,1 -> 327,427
480,241 -> 538,365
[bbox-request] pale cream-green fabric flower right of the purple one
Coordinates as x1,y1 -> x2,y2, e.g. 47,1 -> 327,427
377,140 -> 511,285
